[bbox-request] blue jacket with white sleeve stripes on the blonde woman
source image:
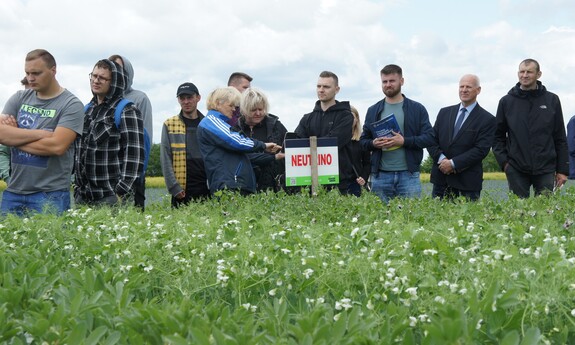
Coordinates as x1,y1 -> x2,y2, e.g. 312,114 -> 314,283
197,110 -> 275,194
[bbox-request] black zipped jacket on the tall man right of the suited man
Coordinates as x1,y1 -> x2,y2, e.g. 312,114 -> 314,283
493,81 -> 569,175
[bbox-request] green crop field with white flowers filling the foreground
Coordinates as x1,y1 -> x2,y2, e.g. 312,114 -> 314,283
0,188 -> 575,344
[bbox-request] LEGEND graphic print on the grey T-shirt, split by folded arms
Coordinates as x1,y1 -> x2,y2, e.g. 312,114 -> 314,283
11,104 -> 56,168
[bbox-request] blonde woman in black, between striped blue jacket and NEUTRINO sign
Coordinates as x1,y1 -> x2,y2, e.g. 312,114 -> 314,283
236,88 -> 287,192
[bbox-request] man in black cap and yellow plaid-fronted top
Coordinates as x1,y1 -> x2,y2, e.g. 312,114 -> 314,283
160,83 -> 210,208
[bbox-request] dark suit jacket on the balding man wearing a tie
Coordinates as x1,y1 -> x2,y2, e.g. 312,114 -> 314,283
427,104 -> 495,191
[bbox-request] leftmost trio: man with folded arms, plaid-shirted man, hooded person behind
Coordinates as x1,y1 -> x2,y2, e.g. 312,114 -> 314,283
0,49 -> 152,215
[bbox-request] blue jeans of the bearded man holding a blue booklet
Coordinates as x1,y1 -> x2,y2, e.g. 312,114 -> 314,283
370,170 -> 421,203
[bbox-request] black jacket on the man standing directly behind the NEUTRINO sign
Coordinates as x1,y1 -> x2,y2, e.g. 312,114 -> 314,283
295,101 -> 356,189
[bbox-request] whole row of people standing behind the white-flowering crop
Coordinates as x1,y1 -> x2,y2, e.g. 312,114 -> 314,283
0,49 -> 575,214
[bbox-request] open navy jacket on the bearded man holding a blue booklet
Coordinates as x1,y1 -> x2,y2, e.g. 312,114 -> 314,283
360,95 -> 435,174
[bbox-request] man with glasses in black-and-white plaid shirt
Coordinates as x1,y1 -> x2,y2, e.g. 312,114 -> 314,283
74,59 -> 144,206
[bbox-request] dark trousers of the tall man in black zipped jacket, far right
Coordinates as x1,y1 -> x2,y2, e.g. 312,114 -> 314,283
505,164 -> 555,198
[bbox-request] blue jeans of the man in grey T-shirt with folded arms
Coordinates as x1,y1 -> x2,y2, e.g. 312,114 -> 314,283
0,190 -> 70,217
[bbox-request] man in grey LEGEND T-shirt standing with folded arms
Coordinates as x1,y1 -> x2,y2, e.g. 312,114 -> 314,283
0,49 -> 83,216
